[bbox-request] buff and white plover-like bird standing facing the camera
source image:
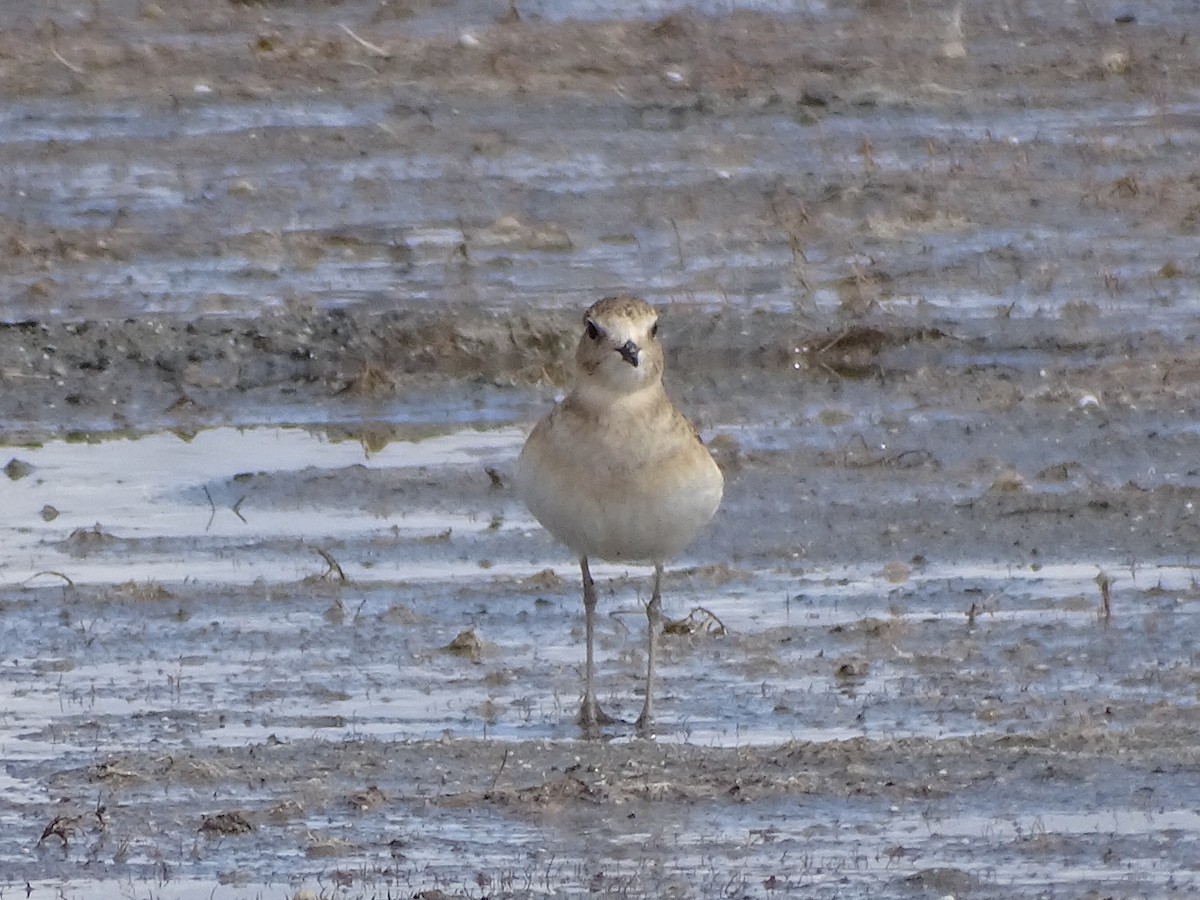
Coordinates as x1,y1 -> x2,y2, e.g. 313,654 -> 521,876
514,295 -> 725,734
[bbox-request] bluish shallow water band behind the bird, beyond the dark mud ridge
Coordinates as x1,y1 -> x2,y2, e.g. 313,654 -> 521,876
9,15 -> 1200,328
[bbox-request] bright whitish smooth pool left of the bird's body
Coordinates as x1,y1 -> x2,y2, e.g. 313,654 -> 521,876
0,428 -> 533,584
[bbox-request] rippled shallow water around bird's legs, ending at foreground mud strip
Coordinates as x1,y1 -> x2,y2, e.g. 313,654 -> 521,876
0,428 -> 1195,756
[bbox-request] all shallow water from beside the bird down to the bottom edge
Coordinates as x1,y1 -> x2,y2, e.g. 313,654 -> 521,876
7,428 -> 1200,898
